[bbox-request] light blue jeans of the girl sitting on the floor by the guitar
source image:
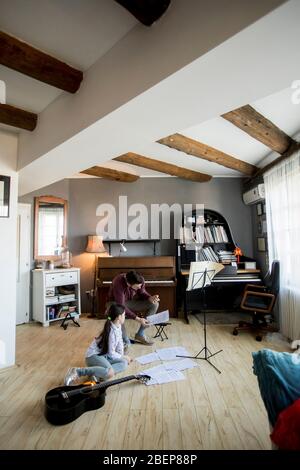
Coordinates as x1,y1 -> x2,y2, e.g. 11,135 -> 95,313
77,354 -> 128,380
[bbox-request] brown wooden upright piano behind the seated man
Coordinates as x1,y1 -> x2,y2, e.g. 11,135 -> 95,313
97,256 -> 177,317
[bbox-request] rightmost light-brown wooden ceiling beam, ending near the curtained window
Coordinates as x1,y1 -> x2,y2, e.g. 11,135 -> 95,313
222,104 -> 293,154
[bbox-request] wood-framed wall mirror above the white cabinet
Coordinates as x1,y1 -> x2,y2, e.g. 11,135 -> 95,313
34,196 -> 68,260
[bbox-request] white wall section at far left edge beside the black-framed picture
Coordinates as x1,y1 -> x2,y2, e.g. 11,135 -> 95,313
0,131 -> 18,369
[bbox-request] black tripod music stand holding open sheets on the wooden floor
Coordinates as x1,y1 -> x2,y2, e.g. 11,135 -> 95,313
177,261 -> 224,374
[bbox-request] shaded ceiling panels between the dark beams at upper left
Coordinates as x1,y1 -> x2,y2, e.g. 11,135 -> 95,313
0,0 -> 137,113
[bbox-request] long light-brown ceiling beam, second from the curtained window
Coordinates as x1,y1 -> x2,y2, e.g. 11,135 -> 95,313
158,134 -> 257,176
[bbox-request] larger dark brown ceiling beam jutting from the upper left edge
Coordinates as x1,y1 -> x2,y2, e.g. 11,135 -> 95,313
0,31 -> 83,93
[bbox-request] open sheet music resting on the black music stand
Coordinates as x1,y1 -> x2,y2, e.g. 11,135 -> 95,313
187,261 -> 224,290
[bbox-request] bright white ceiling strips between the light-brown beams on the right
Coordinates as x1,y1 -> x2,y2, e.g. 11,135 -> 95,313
73,88 -> 300,178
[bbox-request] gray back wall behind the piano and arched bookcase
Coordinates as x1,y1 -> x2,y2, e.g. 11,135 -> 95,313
20,178 -> 253,312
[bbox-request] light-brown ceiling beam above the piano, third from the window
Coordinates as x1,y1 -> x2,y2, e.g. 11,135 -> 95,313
114,152 -> 212,183
